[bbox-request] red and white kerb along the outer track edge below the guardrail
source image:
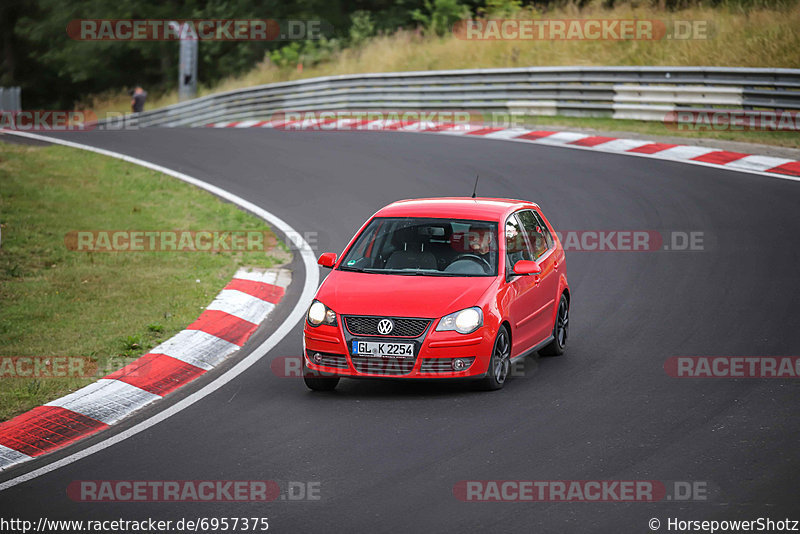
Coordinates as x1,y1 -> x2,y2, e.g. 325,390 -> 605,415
206,119 -> 800,180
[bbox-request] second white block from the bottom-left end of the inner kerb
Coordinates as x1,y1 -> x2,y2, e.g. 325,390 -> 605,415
45,378 -> 161,425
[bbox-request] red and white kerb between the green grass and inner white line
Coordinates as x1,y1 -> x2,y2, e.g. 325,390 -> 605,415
0,269 -> 291,470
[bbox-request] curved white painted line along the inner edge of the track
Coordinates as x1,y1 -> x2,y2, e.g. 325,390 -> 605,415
0,130 -> 319,491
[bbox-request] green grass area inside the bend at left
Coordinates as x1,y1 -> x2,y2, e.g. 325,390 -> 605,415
0,143 -> 290,420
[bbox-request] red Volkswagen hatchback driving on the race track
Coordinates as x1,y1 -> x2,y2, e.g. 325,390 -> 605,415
303,198 -> 570,390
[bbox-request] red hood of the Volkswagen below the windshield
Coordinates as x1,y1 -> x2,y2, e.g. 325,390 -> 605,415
317,270 -> 496,318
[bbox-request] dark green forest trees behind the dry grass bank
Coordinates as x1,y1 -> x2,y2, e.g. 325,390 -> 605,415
0,0 -> 764,109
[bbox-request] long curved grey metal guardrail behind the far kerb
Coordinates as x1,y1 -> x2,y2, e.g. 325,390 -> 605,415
106,67 -> 800,127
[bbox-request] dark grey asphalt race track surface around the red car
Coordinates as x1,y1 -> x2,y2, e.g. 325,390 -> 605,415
0,129 -> 800,533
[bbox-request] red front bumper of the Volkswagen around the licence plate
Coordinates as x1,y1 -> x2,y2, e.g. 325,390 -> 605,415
303,320 -> 494,378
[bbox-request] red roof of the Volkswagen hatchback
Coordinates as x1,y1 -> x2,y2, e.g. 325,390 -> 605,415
375,197 -> 539,221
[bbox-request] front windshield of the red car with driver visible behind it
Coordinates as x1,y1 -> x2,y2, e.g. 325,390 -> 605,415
339,217 -> 498,276
